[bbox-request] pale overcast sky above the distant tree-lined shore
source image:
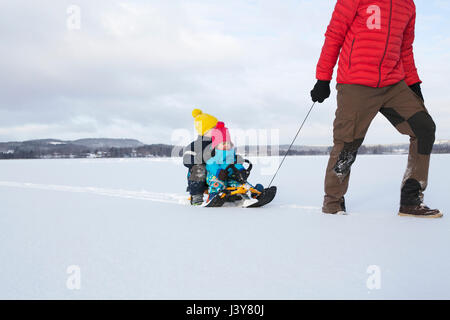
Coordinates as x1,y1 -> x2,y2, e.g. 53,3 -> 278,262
0,0 -> 450,145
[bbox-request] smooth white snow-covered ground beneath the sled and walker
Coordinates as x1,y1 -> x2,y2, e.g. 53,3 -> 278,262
0,155 -> 450,299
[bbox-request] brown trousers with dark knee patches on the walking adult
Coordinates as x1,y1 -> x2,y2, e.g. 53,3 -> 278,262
322,81 -> 436,213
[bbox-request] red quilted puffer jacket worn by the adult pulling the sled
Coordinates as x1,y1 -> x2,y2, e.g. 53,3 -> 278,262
316,0 -> 421,87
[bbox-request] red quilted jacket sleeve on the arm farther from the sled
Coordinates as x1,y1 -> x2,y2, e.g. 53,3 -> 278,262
401,12 -> 422,86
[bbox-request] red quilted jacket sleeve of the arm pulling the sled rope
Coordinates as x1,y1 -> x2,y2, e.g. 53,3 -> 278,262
316,0 -> 359,81
